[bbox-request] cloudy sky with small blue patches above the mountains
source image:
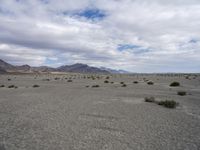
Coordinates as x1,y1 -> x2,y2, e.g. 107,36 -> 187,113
0,0 -> 200,73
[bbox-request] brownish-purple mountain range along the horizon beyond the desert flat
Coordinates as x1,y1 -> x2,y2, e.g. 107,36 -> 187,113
0,59 -> 129,74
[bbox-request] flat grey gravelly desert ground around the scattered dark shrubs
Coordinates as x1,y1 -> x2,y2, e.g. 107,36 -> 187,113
0,74 -> 200,150
